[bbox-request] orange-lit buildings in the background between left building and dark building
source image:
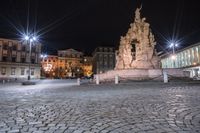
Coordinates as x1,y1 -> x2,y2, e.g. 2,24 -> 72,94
41,49 -> 92,78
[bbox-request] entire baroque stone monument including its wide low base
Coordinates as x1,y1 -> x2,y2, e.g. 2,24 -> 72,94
95,8 -> 188,82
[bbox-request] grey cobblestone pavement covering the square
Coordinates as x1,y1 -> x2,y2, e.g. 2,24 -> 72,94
0,82 -> 200,133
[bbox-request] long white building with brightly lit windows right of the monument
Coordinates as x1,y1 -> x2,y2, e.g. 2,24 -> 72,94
161,43 -> 200,77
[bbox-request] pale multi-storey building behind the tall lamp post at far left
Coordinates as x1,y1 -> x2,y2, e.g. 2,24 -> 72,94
0,38 -> 41,79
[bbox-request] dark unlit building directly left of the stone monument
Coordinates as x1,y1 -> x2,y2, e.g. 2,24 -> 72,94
92,47 -> 116,74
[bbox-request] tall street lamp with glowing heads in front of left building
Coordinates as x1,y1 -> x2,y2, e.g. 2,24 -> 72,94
24,34 -> 37,80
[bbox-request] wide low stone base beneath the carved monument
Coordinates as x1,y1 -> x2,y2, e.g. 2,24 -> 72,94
96,69 -> 190,82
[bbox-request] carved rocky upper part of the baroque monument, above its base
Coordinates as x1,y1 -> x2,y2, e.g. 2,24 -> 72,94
115,8 -> 160,70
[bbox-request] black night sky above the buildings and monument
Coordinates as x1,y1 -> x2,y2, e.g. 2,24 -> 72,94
0,0 -> 200,54
